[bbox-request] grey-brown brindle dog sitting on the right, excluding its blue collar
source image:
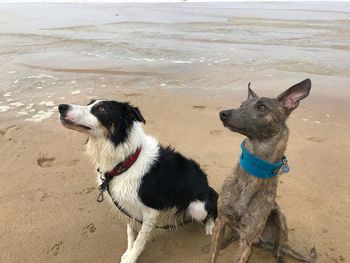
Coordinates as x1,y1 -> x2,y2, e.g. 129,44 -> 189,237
209,79 -> 316,263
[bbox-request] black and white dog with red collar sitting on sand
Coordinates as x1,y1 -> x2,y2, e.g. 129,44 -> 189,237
58,100 -> 218,263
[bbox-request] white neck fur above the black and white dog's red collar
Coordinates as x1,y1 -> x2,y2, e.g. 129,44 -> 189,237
87,122 -> 149,172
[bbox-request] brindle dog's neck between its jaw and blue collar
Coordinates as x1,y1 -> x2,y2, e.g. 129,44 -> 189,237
244,127 -> 289,162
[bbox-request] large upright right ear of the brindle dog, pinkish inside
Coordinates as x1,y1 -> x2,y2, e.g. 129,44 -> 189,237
277,79 -> 311,111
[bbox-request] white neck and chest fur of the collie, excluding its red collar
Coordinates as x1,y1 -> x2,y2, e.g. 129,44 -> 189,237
87,122 -> 159,220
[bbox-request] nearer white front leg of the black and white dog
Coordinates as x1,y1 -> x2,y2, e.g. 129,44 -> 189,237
121,209 -> 159,263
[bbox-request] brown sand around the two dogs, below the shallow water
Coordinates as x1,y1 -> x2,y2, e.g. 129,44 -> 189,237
0,86 -> 350,262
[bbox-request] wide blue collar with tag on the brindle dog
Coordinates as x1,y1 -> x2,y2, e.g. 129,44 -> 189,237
239,141 -> 289,179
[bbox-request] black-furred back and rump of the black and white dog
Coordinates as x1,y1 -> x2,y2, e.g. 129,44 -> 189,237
139,147 -> 217,224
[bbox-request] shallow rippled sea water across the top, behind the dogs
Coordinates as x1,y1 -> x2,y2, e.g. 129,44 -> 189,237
0,1 -> 350,119
